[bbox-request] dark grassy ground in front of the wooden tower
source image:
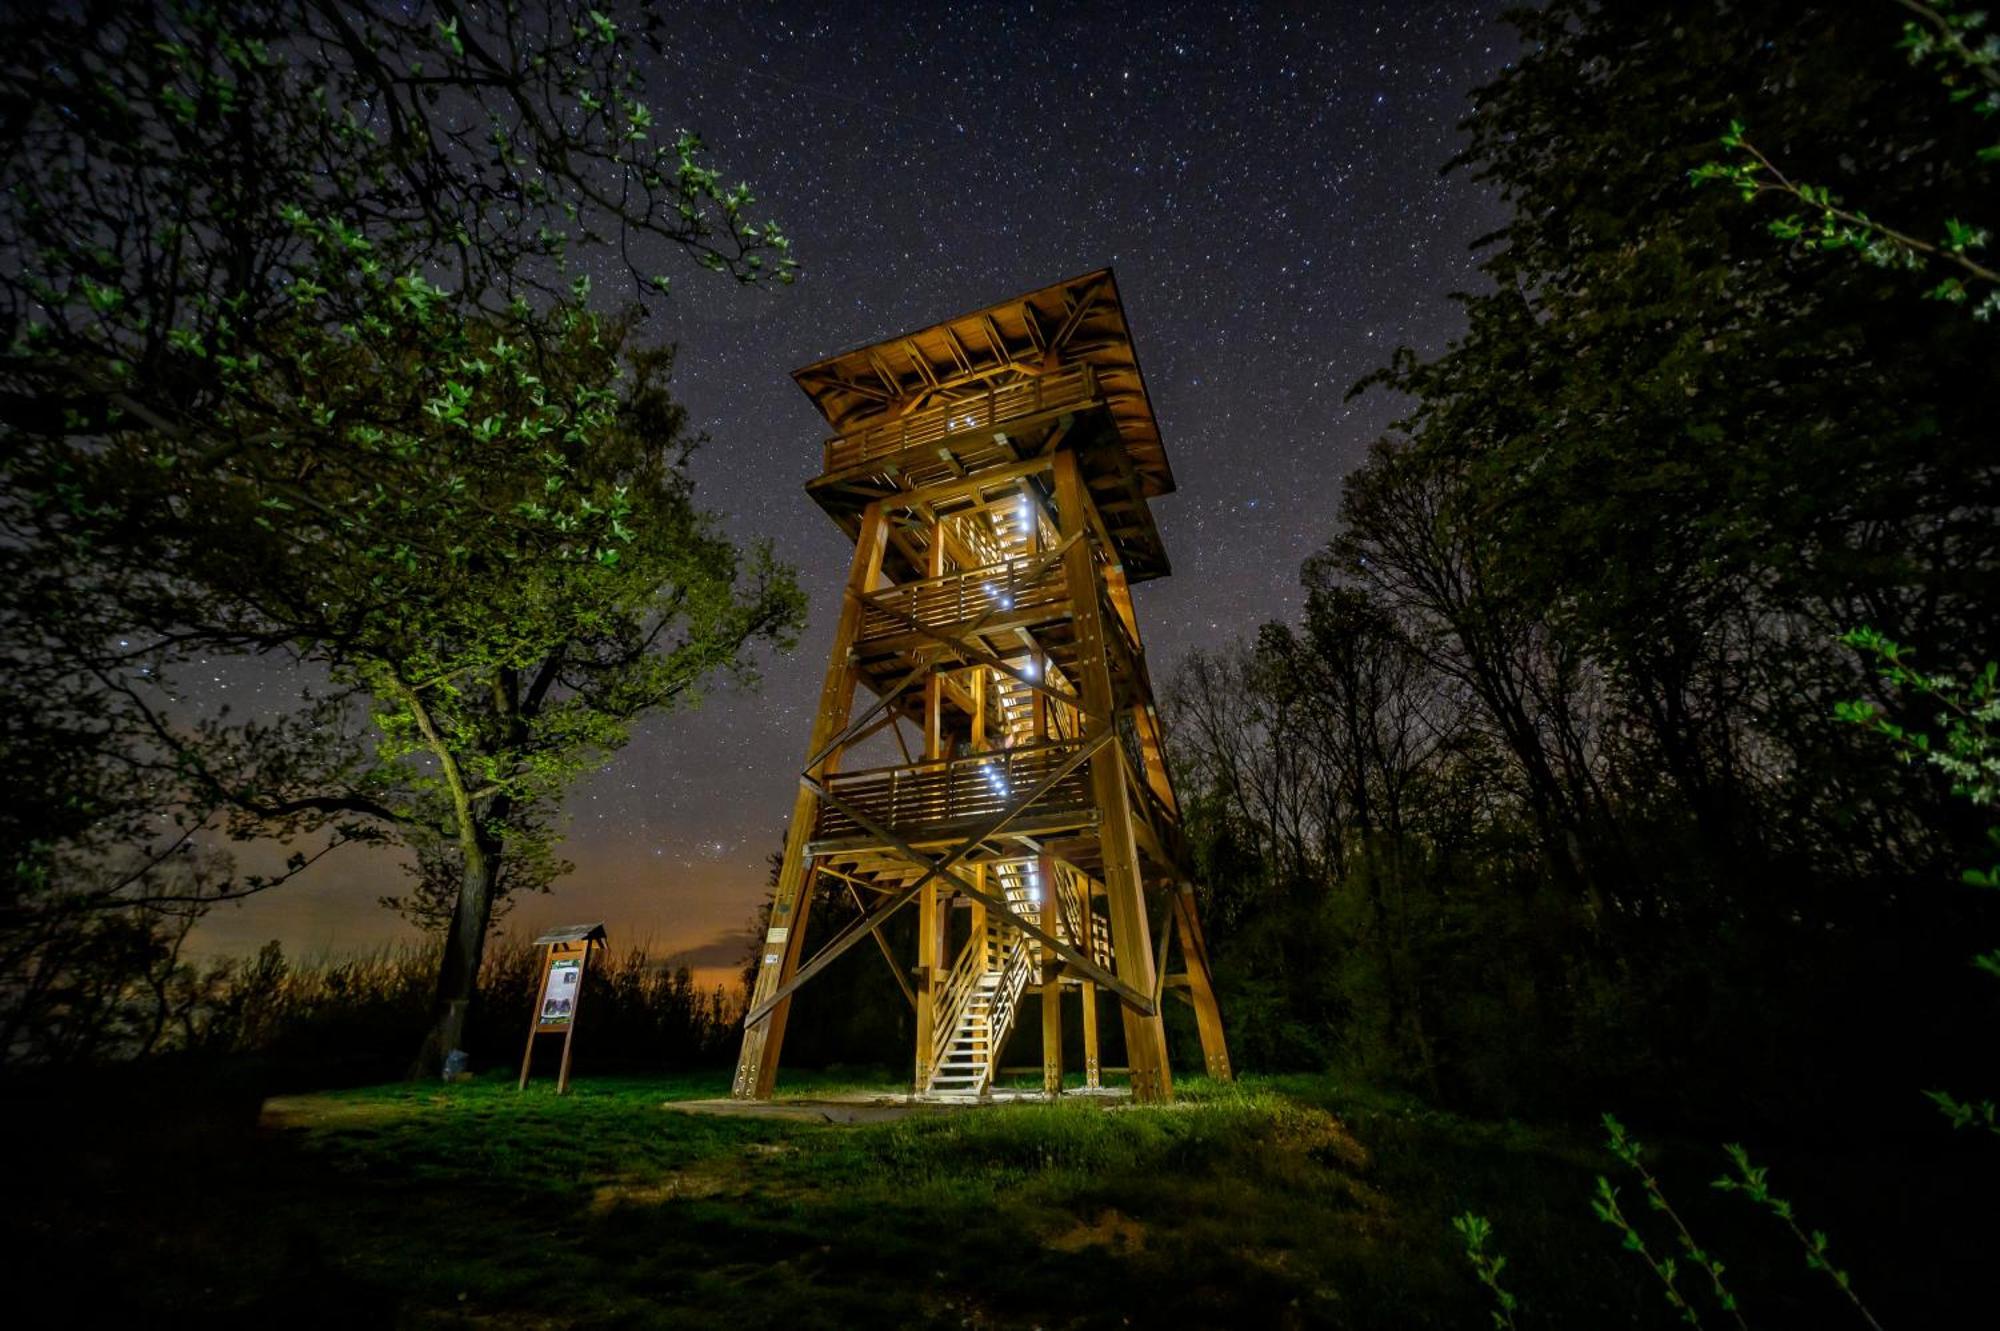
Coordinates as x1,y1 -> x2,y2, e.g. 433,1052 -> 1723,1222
4,1073 -> 1984,1327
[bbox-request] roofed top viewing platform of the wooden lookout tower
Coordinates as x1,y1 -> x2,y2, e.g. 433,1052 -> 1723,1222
792,268 -> 1174,582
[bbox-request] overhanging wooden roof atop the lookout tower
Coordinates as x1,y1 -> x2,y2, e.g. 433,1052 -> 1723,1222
792,268 -> 1174,500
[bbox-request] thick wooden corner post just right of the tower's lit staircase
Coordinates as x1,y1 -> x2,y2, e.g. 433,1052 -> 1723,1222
1056,452 -> 1174,1103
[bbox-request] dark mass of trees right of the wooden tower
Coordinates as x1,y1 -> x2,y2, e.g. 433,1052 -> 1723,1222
1170,4 -> 2000,1123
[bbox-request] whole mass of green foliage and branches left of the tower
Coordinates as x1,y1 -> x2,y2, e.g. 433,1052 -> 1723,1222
0,0 -> 796,1055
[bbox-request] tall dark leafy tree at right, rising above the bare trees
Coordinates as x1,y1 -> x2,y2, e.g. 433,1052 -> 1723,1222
1350,4 -> 2000,909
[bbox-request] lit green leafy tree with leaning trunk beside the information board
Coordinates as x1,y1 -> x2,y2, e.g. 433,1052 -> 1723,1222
129,296 -> 804,1067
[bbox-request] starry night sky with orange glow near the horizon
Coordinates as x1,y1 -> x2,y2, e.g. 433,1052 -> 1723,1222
194,0 -> 1512,977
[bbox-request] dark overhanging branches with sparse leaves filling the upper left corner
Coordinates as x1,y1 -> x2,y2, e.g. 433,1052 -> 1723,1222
0,0 -> 792,1055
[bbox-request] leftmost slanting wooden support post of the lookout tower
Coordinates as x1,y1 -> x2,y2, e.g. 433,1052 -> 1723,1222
730,502 -> 888,1099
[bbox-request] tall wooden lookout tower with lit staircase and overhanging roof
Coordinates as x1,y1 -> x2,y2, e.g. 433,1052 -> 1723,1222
734,270 -> 1230,1101
